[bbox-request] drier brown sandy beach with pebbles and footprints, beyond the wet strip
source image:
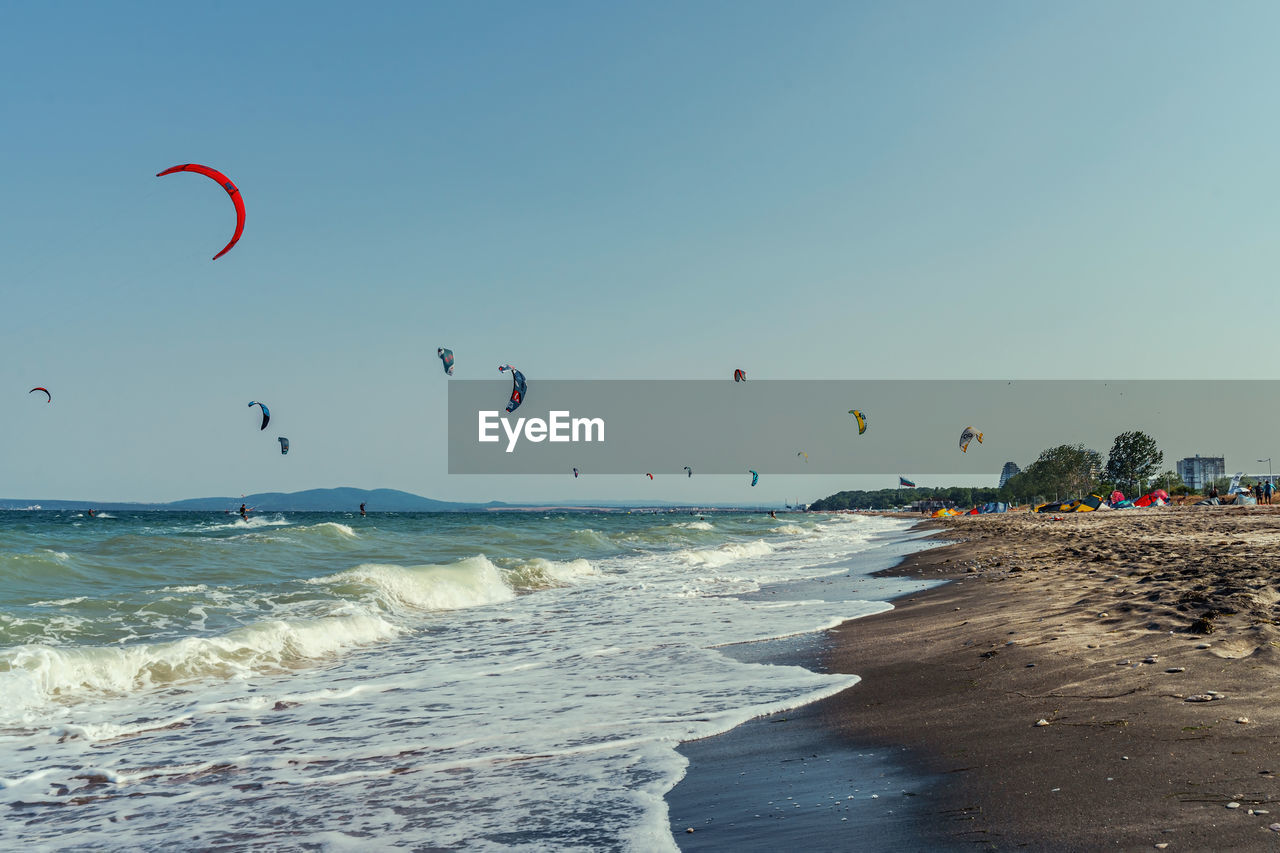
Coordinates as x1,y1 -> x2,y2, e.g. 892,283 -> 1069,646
820,507 -> 1280,850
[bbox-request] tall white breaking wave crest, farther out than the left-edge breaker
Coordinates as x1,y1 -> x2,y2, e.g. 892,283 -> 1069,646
307,555 -> 516,612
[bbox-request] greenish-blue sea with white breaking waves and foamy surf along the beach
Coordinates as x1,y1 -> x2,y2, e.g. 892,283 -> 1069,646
0,511 -> 918,853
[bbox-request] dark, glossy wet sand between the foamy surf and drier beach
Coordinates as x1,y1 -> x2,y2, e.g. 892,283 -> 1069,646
666,519 -> 960,853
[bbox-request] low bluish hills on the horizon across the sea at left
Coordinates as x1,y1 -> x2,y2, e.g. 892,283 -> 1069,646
0,487 -> 508,512
